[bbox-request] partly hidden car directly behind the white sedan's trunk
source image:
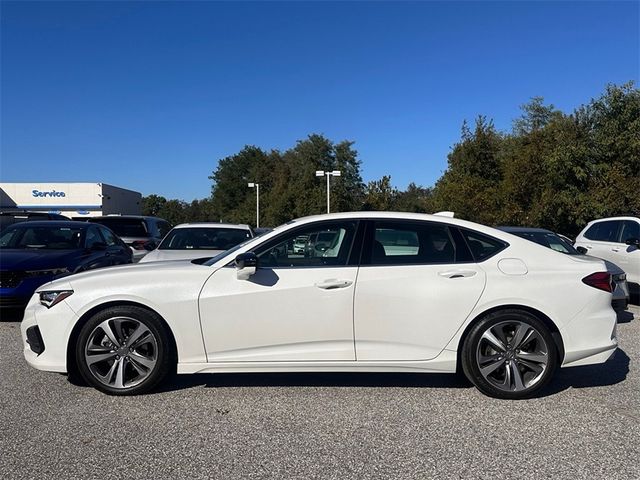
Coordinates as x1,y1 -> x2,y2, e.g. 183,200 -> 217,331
498,227 -> 629,311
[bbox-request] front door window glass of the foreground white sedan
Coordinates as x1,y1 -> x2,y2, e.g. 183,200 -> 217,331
256,222 -> 357,268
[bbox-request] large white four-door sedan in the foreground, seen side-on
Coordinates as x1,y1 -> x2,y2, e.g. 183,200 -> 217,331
22,212 -> 617,398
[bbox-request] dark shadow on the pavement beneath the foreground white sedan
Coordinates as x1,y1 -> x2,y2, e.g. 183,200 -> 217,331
156,349 -> 630,398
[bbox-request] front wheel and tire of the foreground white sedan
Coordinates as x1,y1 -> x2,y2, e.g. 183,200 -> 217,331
75,305 -> 177,395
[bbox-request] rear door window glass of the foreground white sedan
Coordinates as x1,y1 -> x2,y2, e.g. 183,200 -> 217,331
371,222 -> 456,265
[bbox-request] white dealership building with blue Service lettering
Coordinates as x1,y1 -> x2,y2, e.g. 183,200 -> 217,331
0,183 -> 142,218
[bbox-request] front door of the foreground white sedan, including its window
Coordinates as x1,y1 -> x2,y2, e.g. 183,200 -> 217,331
200,220 -> 358,362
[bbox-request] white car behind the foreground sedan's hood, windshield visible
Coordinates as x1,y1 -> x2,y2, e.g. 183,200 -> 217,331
140,222 -> 254,263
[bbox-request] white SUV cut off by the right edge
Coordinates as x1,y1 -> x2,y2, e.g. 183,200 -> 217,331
574,217 -> 640,284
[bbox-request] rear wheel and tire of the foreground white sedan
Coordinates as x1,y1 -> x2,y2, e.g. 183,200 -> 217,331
461,309 -> 558,400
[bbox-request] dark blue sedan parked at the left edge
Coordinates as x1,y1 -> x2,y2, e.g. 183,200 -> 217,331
0,220 -> 132,310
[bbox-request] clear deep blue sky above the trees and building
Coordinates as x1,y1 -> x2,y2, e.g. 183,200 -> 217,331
0,1 -> 640,201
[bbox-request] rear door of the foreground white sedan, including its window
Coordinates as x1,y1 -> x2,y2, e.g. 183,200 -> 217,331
354,220 -> 486,361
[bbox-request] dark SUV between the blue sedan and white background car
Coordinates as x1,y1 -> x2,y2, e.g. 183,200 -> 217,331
85,215 -> 171,262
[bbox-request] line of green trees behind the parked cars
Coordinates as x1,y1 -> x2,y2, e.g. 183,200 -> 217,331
143,83 -> 640,235
